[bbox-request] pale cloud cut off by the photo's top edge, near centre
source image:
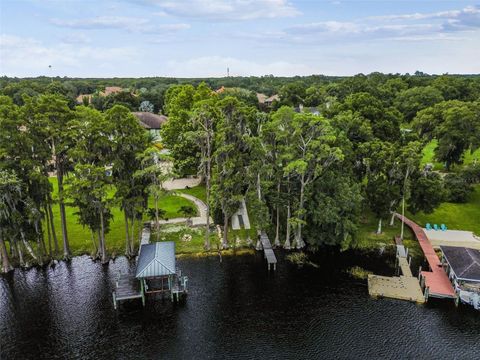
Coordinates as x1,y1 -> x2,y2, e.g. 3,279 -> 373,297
137,0 -> 300,20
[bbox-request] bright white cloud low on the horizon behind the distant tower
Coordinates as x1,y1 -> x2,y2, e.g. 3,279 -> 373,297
166,56 -> 314,77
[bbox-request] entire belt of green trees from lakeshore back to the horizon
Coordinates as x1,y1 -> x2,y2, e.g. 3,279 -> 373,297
0,73 -> 480,270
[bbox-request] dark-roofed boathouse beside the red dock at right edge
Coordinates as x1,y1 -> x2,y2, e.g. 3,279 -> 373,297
440,246 -> 480,309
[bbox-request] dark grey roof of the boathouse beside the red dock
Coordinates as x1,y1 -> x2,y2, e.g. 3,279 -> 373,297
440,246 -> 480,281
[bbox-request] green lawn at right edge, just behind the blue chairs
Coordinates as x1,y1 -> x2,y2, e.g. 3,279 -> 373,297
410,185 -> 480,235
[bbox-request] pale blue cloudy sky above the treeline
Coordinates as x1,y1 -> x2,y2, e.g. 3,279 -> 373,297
0,0 -> 480,77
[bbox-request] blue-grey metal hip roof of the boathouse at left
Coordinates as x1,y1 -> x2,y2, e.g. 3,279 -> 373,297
135,241 -> 175,278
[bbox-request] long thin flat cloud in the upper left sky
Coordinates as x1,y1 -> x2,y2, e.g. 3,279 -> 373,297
50,16 -> 190,34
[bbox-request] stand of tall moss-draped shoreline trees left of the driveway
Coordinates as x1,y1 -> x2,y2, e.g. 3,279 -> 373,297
0,94 -> 151,271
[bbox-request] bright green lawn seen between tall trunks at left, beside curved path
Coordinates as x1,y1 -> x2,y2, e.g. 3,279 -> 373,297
50,178 -> 196,255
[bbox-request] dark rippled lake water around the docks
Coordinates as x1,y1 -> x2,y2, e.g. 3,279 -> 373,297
0,249 -> 480,360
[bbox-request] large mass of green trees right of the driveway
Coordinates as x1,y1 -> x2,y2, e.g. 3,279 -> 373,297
162,75 -> 480,248
